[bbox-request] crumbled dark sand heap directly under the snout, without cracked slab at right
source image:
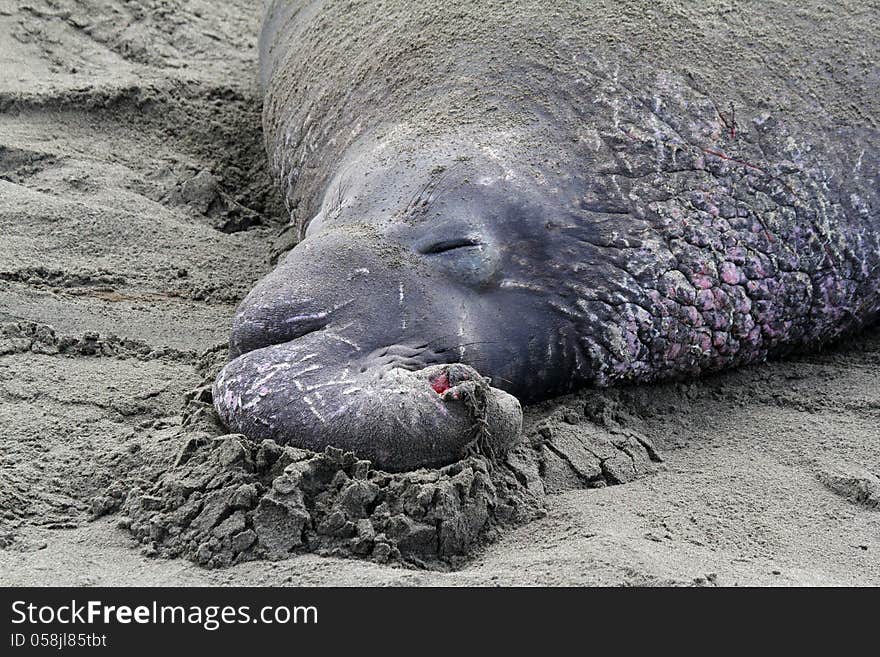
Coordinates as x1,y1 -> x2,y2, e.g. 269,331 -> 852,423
120,434 -> 541,566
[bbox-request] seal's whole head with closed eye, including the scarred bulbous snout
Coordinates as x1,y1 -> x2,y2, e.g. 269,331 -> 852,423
215,133 -> 565,469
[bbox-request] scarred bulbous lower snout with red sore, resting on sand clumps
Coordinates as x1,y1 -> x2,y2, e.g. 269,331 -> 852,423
214,331 -> 522,471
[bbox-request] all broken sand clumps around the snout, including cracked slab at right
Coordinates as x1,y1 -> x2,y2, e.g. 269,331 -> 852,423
91,348 -> 660,570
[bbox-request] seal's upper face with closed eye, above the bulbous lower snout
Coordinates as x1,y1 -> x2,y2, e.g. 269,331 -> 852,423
223,131 -> 572,401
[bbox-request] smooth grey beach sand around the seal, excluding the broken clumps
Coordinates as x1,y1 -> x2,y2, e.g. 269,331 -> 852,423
0,0 -> 880,586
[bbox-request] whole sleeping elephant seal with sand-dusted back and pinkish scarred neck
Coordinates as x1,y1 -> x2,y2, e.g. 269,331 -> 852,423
214,0 -> 880,470
